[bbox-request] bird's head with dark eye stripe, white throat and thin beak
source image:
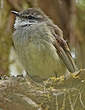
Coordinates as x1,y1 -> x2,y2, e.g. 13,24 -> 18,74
12,8 -> 46,29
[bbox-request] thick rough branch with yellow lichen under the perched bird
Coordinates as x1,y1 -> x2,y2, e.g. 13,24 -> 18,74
0,70 -> 85,110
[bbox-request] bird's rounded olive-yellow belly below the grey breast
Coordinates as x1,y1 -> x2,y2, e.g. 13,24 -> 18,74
18,41 -> 65,79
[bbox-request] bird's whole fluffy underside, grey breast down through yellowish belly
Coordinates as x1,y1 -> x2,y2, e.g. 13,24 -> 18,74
14,23 -> 66,79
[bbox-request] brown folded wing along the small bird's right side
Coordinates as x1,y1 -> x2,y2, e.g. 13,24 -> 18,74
47,24 -> 77,73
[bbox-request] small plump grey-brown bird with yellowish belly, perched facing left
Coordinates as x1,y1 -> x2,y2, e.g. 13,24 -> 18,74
12,8 -> 77,81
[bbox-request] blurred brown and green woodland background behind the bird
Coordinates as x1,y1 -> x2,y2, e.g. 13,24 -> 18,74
0,0 -> 85,75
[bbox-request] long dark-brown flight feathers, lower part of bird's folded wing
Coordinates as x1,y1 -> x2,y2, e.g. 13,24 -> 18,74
54,42 -> 77,73
